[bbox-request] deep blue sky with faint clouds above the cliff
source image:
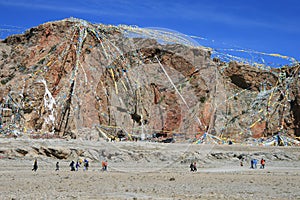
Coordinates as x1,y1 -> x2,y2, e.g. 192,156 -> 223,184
0,0 -> 300,63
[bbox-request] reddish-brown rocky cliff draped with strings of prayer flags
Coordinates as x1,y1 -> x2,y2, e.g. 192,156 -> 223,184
0,19 -> 300,140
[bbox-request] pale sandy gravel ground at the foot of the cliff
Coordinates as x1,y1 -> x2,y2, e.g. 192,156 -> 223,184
0,139 -> 300,199
